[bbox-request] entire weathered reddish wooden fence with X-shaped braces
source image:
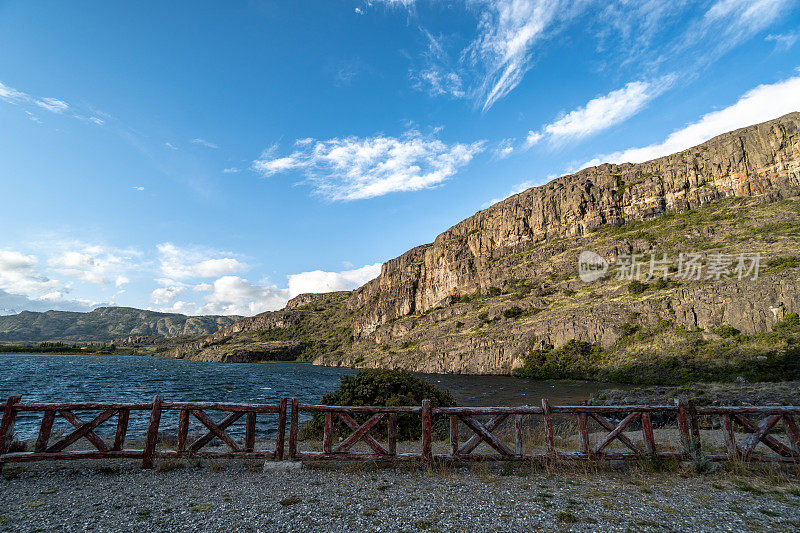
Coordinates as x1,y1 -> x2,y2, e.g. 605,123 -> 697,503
0,396 -> 800,468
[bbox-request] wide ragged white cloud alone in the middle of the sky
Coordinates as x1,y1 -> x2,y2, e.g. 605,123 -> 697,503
253,129 -> 484,200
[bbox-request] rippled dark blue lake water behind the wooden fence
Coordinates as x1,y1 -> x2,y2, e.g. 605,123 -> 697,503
0,354 -> 609,440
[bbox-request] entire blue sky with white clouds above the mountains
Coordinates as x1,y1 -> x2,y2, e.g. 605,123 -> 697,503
0,0 -> 800,315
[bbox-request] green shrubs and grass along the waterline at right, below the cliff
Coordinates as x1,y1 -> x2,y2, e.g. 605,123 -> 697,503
516,313 -> 800,385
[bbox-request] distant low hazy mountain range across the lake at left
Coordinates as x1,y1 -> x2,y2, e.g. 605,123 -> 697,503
0,307 -> 241,342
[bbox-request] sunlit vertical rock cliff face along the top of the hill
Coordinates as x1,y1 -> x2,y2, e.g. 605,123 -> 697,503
348,113 -> 800,339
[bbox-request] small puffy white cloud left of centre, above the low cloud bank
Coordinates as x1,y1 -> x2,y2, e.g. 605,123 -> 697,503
157,242 -> 248,279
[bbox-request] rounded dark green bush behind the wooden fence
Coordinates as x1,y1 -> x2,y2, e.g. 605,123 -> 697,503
302,369 -> 456,440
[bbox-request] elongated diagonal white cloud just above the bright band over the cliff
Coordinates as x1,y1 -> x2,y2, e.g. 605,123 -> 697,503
526,76 -> 675,146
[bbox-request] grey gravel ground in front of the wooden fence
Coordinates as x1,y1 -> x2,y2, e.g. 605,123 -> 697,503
0,461 -> 800,532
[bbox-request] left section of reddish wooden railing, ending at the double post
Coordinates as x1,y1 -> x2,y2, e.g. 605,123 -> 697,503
0,395 -> 287,468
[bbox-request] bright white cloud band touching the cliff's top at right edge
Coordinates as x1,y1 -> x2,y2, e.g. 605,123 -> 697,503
581,72 -> 800,168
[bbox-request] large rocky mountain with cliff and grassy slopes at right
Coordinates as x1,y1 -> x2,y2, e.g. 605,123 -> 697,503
173,113 -> 800,378
